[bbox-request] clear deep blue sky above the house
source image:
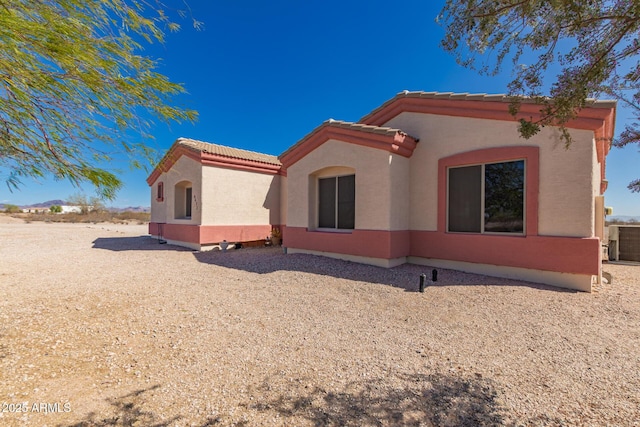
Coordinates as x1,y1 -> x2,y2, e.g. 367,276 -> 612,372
5,0 -> 640,215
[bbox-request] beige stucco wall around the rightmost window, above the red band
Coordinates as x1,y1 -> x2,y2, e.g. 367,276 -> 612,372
385,113 -> 599,237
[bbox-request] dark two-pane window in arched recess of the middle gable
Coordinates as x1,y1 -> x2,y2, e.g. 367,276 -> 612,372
318,175 -> 356,230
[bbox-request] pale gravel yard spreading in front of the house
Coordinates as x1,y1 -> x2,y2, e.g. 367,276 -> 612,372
0,216 -> 640,427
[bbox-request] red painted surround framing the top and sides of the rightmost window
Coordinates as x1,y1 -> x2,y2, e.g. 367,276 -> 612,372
438,145 -> 540,236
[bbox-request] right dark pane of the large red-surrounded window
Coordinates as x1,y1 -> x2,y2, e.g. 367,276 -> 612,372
484,160 -> 524,233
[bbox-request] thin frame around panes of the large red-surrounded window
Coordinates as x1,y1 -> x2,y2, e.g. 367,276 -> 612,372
445,157 -> 529,236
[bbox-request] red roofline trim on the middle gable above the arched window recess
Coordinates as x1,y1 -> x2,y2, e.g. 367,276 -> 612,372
280,123 -> 417,167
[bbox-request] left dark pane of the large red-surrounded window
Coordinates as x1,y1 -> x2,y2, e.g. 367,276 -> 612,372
449,166 -> 482,233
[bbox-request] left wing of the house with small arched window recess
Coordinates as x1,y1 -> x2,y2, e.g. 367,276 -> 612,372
147,138 -> 282,250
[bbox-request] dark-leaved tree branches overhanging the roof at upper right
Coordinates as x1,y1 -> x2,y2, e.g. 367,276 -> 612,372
438,0 -> 640,192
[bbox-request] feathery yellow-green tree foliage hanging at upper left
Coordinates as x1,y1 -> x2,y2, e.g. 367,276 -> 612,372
0,0 -> 199,198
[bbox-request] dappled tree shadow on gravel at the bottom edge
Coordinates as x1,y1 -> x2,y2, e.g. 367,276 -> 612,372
243,374 -> 505,427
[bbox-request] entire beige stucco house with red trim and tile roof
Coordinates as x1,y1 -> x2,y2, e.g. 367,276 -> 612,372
148,91 -> 616,291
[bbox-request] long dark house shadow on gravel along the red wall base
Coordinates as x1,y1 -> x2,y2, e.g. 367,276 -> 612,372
193,248 -> 577,293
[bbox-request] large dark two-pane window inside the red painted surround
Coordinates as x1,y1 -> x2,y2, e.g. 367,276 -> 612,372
447,160 -> 525,233
